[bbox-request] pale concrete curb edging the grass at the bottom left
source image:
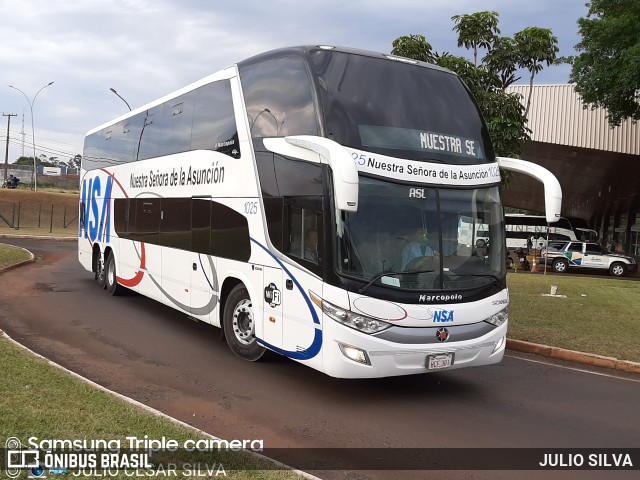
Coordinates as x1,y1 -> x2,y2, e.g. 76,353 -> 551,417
0,329 -> 321,480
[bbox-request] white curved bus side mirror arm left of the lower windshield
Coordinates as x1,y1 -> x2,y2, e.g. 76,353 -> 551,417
263,135 -> 358,212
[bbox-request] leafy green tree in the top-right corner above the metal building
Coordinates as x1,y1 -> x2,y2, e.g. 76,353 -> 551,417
569,0 -> 640,126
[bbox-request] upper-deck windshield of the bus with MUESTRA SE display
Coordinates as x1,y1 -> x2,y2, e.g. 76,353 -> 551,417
311,50 -> 494,165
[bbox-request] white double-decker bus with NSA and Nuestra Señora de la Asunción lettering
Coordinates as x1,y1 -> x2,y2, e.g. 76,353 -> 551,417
79,46 -> 561,378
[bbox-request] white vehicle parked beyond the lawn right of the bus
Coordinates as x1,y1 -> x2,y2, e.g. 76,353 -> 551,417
541,242 -> 638,277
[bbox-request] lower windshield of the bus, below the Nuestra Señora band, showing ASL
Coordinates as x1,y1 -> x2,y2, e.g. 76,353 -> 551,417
337,176 -> 506,290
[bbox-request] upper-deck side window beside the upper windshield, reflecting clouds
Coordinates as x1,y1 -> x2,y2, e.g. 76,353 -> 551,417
240,56 -> 318,137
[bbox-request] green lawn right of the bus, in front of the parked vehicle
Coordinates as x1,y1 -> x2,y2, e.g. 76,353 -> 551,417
507,274 -> 640,362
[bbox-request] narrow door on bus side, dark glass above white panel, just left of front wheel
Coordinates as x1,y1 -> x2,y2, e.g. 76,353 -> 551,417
189,197 -> 219,326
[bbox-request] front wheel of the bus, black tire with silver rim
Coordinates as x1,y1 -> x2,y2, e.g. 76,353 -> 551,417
222,284 -> 266,362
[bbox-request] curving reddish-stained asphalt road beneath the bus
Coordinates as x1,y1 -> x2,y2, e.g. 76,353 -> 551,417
0,239 -> 640,479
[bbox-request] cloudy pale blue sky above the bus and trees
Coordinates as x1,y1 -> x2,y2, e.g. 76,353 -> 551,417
0,0 -> 587,163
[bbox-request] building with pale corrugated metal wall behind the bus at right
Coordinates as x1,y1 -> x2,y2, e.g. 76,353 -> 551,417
505,84 -> 640,256
